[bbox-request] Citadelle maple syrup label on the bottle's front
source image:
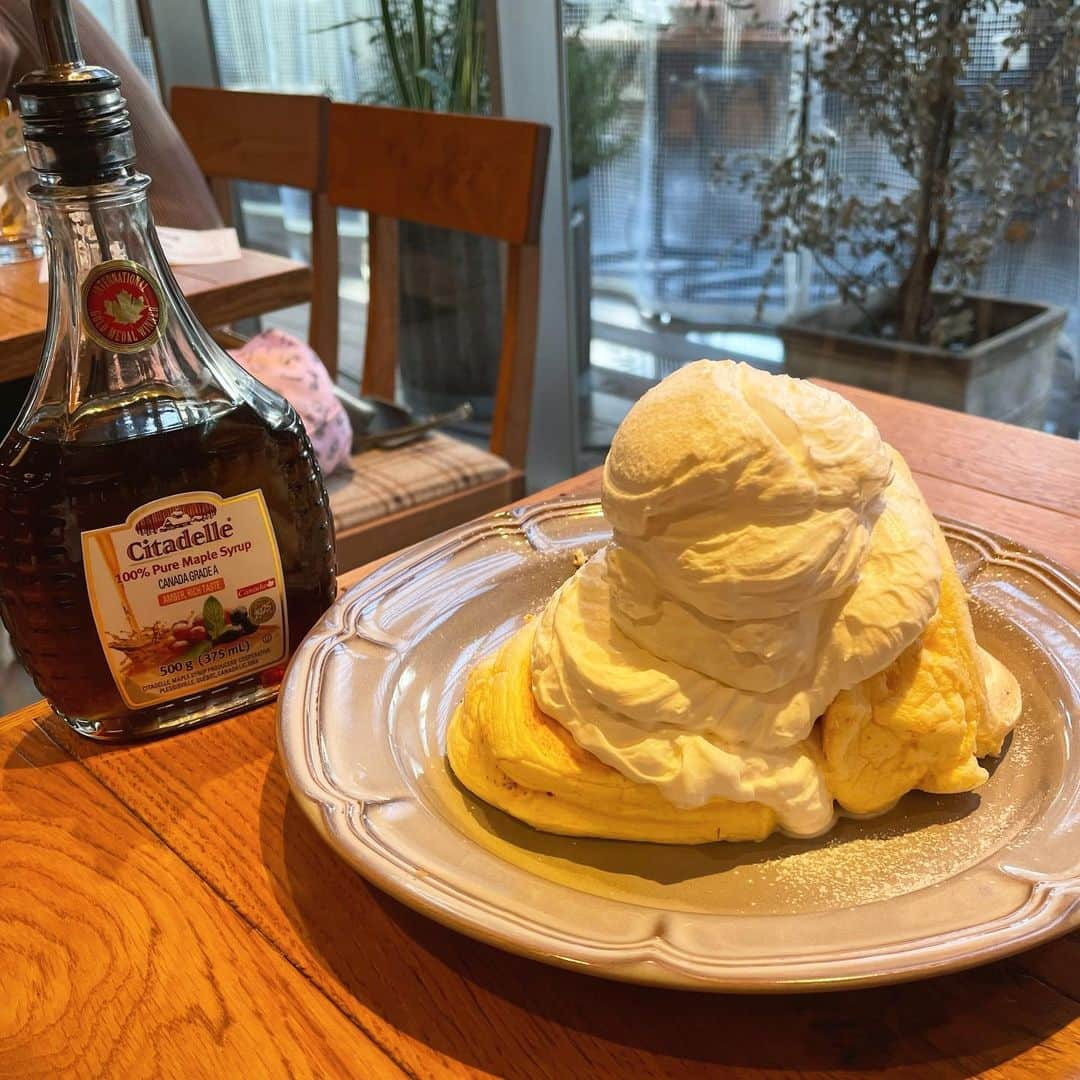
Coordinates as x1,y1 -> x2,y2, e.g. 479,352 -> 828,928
82,491 -> 288,708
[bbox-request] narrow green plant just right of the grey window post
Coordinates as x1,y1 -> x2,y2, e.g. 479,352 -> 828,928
565,26 -> 634,418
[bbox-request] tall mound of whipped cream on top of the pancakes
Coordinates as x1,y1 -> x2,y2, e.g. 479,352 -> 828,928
532,361 -> 942,836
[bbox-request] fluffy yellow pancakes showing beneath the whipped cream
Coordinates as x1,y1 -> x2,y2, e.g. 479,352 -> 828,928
447,525 -> 1021,843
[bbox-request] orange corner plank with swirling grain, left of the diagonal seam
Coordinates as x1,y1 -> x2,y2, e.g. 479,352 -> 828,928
0,712 -> 395,1077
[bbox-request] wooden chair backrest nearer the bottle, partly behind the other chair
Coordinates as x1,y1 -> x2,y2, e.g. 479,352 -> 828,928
172,86 -> 338,376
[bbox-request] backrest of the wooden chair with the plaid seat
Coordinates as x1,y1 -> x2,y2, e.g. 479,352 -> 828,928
326,104 -> 551,469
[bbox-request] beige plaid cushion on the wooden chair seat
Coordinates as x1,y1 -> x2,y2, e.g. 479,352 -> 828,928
326,432 -> 510,530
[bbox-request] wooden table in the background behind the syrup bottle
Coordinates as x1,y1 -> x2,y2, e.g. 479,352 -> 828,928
0,247 -> 311,382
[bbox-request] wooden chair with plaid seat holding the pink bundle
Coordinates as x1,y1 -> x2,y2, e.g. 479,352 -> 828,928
326,104 -> 550,568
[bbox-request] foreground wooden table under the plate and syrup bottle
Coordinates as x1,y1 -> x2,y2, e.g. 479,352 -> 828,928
0,390 -> 1080,1080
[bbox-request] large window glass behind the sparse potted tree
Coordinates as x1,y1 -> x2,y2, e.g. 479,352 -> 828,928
564,0 -> 1080,462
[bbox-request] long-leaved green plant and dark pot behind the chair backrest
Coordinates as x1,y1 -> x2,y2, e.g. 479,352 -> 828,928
328,0 -> 494,419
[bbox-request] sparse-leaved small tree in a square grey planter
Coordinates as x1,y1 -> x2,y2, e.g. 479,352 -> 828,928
742,0 -> 1080,424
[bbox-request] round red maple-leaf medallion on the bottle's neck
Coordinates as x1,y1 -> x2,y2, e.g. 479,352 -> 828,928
82,259 -> 166,352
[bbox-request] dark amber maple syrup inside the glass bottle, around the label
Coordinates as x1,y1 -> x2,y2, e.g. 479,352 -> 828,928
0,404 -> 336,739
